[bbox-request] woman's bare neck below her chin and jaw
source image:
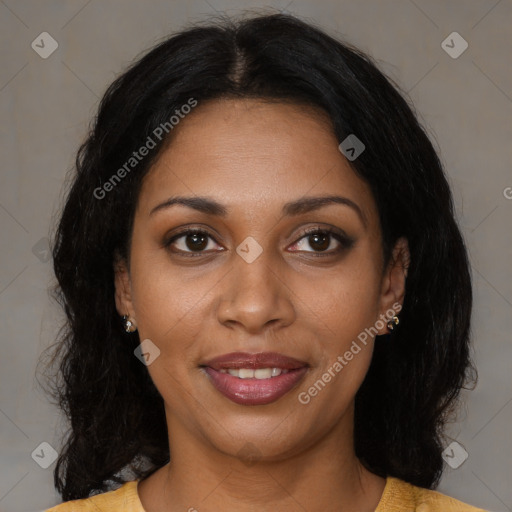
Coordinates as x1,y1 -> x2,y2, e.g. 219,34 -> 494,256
139,406 -> 385,512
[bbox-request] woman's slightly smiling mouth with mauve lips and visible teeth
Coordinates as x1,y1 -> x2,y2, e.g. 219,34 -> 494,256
200,352 -> 309,405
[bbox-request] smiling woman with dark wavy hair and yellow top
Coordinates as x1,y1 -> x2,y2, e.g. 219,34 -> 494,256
43,10 -> 484,512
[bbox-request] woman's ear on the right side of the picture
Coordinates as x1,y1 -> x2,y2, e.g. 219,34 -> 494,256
379,237 -> 410,334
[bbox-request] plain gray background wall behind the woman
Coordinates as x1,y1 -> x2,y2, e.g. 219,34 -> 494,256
0,0 -> 512,512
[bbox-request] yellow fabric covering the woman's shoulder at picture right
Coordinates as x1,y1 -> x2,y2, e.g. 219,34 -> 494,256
376,477 -> 486,512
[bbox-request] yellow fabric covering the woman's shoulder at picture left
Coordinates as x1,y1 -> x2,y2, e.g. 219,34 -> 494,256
45,480 -> 144,512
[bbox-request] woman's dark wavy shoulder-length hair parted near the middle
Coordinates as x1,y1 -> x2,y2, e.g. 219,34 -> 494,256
40,13 -> 476,501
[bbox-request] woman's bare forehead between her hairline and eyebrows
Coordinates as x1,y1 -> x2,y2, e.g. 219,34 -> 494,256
138,99 -> 375,225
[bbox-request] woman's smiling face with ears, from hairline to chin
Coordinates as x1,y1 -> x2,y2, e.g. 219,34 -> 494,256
116,100 -> 407,459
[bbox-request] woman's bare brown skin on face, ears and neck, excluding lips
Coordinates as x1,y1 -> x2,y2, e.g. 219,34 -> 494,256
115,99 -> 409,512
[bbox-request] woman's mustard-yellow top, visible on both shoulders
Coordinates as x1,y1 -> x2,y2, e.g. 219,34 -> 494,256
45,477 -> 486,512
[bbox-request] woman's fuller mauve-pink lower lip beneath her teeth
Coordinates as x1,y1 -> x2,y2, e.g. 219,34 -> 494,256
204,366 -> 308,405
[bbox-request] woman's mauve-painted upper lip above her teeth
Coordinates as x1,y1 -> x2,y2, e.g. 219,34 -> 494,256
201,352 -> 307,370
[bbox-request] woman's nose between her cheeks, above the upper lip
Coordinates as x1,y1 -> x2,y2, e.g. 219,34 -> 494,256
217,251 -> 296,334
